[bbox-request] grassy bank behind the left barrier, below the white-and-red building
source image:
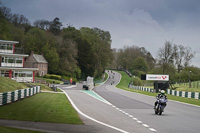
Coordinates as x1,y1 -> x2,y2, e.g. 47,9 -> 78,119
0,77 -> 28,93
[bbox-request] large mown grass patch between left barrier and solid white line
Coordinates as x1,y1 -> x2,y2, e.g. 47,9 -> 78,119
0,93 -> 83,124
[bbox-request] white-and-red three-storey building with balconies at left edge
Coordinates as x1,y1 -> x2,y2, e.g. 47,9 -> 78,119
0,40 -> 38,82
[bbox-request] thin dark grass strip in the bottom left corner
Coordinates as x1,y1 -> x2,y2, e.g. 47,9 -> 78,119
0,127 -> 42,133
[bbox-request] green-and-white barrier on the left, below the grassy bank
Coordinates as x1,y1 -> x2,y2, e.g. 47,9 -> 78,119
0,86 -> 40,105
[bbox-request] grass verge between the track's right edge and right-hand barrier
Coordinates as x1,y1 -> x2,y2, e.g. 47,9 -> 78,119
116,71 -> 200,106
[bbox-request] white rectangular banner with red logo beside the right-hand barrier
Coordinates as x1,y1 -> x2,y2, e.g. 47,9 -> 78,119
146,74 -> 169,81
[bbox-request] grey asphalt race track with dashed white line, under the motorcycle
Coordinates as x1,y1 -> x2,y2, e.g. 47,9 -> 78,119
61,71 -> 200,133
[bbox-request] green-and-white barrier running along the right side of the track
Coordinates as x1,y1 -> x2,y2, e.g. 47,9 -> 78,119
129,85 -> 200,99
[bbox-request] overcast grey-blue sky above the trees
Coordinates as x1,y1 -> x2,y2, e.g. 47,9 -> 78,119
2,0 -> 200,67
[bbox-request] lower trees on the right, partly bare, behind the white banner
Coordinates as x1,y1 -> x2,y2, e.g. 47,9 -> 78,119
111,41 -> 200,83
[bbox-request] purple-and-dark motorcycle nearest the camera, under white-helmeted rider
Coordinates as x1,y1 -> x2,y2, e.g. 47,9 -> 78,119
154,97 -> 168,115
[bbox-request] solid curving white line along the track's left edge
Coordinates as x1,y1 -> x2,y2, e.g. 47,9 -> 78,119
60,88 -> 129,133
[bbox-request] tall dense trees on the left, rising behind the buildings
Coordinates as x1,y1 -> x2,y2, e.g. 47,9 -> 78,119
0,5 -> 113,79
